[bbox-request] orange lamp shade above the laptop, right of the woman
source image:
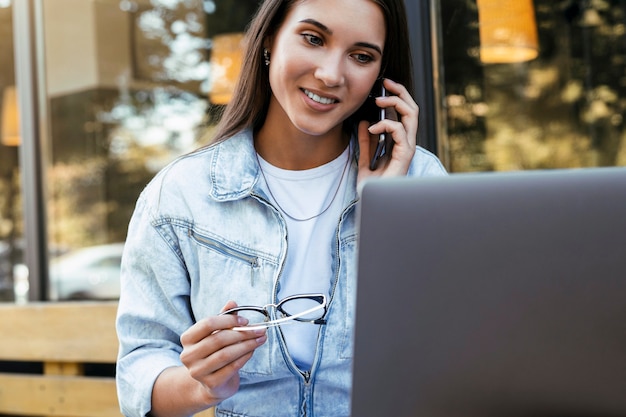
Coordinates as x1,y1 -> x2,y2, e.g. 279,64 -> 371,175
477,0 -> 539,64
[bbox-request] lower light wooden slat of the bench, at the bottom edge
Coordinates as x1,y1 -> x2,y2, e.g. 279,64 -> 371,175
0,373 -> 121,417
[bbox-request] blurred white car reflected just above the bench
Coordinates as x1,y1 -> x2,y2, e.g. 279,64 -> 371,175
50,243 -> 124,300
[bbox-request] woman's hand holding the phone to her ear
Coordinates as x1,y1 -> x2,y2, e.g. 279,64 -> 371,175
357,79 -> 419,183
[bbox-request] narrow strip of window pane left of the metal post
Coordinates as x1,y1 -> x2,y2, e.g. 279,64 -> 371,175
0,0 -> 28,302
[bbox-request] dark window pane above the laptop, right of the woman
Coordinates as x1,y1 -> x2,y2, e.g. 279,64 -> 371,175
439,0 -> 626,172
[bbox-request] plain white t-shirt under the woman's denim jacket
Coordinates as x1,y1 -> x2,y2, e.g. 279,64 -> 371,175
259,146 -> 350,370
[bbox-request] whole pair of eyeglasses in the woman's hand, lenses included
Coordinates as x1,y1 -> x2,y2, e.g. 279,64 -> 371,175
220,294 -> 326,331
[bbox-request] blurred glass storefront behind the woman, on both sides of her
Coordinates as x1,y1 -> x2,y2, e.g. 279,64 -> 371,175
0,0 -> 626,303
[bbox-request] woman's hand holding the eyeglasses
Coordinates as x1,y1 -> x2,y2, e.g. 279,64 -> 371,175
180,301 -> 267,403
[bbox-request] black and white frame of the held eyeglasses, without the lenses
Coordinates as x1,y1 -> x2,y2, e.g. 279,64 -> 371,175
220,294 -> 328,331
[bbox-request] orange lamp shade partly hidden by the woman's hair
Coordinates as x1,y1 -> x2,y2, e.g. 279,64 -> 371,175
209,33 -> 243,104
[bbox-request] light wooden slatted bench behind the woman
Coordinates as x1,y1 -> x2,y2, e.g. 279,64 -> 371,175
0,302 -> 213,417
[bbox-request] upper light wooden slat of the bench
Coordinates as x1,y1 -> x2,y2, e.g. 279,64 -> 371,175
0,302 -> 118,363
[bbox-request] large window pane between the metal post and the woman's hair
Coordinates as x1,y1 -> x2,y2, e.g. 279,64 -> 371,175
41,0 -> 258,299
